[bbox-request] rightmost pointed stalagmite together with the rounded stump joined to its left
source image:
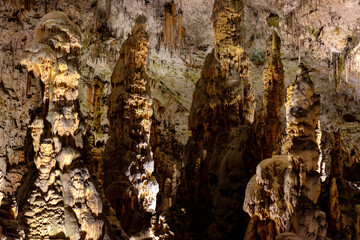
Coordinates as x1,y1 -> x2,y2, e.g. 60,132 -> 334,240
244,65 -> 327,239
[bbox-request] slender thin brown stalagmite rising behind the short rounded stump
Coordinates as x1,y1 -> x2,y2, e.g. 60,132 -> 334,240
262,31 -> 285,158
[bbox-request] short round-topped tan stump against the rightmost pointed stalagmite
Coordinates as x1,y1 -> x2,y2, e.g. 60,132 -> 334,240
244,155 -> 290,236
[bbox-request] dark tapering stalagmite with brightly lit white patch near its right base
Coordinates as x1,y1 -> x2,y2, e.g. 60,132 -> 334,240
104,16 -> 159,233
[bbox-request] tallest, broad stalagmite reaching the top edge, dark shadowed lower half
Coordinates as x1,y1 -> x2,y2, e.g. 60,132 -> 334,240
180,0 -> 256,239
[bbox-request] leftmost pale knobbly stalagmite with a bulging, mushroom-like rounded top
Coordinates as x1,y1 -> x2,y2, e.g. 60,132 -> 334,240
19,12 -> 104,239
